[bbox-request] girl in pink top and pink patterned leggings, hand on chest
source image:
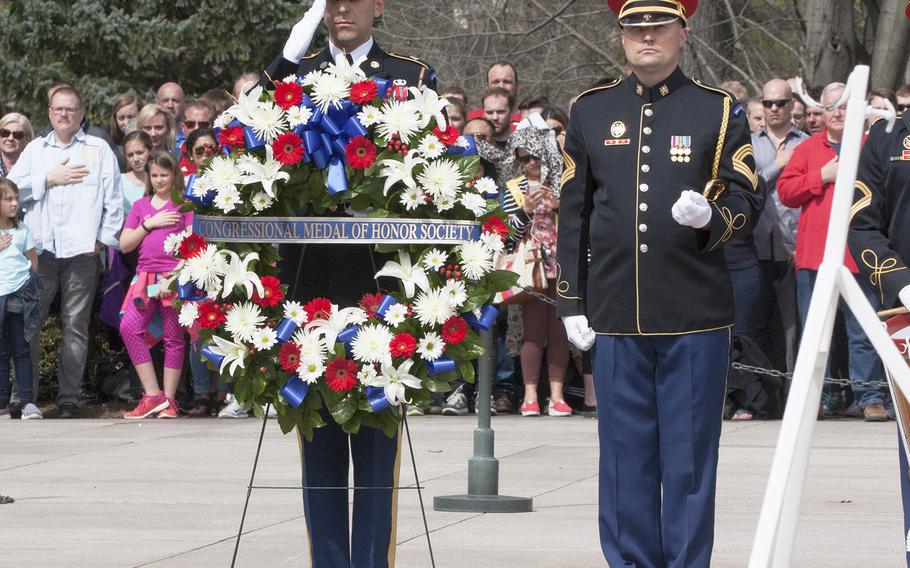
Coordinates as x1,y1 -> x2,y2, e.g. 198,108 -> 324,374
120,152 -> 193,419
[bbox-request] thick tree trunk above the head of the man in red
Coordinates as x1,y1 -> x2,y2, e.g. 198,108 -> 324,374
805,0 -> 859,85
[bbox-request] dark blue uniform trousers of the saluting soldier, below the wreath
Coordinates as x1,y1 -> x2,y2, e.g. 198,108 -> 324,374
301,414 -> 401,568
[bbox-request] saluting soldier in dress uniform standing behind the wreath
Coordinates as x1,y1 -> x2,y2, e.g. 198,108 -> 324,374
261,0 -> 436,568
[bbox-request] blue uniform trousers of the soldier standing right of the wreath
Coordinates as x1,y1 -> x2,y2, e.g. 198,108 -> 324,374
594,328 -> 731,568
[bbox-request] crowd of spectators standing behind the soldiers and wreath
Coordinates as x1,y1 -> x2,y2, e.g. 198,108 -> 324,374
0,61 -> 910,421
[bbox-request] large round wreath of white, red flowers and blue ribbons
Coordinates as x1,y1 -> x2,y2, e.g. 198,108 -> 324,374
165,56 -> 516,439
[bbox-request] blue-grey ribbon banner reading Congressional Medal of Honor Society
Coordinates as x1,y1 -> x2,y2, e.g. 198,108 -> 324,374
193,215 -> 481,245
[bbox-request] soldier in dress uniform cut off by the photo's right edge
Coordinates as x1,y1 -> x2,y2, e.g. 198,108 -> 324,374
848,2 -> 910,566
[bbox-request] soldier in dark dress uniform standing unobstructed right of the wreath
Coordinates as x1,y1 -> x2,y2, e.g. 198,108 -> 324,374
557,0 -> 764,568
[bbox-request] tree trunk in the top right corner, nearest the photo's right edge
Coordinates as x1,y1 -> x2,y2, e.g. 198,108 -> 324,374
870,0 -> 910,89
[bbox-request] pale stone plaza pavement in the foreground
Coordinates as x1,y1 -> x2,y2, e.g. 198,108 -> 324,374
0,416 -> 903,568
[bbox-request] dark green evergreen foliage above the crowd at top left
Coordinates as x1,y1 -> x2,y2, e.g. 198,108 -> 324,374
0,0 -> 320,125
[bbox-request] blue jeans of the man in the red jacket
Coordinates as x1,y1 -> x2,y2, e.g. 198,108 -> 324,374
796,269 -> 885,407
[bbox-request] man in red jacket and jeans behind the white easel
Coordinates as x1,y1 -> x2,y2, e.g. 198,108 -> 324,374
777,83 -> 888,422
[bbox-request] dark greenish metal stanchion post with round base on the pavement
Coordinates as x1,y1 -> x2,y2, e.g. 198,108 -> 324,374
433,329 -> 533,513
